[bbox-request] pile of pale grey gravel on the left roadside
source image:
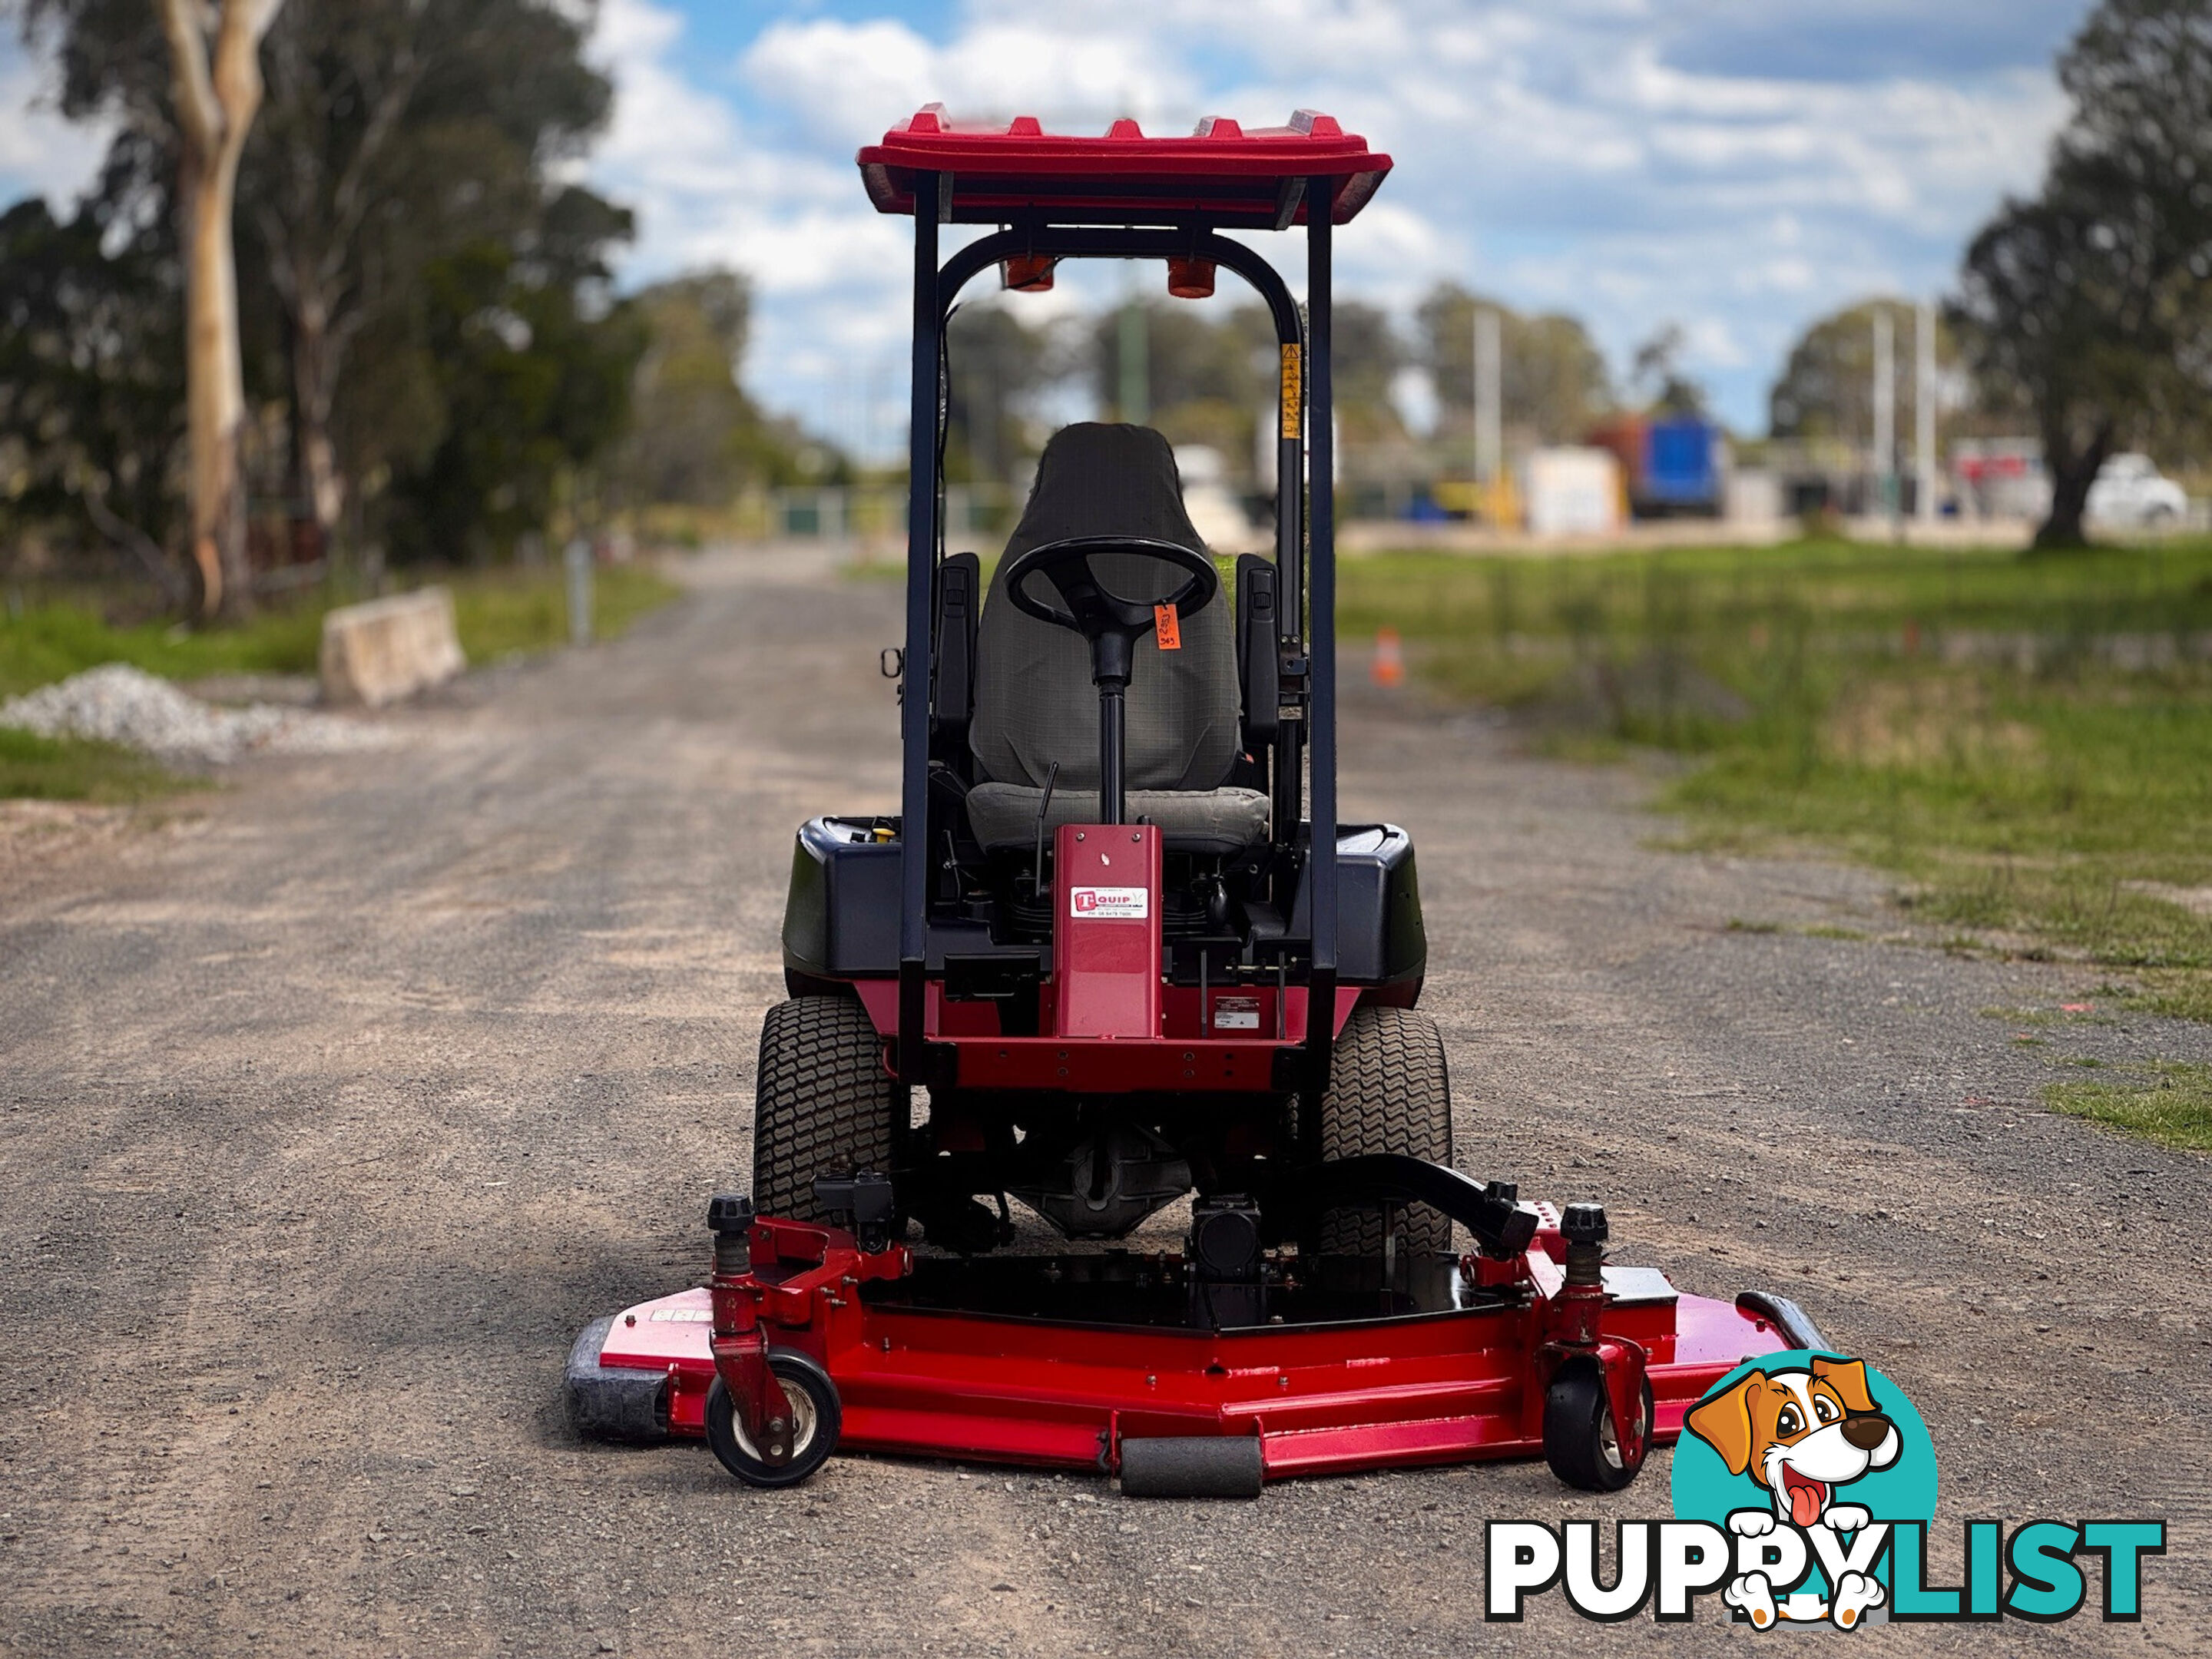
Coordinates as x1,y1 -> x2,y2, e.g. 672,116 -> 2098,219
0,661 -> 392,765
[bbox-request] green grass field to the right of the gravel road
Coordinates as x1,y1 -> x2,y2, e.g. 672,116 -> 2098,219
1340,542 -> 2212,1018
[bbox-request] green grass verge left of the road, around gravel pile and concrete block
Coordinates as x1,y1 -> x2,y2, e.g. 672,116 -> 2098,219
0,564 -> 679,801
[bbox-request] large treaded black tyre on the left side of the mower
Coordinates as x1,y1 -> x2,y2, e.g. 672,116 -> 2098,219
752,995 -> 900,1221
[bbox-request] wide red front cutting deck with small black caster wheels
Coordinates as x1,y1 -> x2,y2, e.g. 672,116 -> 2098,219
568,1201 -> 1823,1498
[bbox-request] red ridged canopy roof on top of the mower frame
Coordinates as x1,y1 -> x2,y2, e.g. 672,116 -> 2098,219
860,104 -> 1389,230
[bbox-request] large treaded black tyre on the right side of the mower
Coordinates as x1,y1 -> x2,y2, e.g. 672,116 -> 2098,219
1299,1008 -> 1451,1257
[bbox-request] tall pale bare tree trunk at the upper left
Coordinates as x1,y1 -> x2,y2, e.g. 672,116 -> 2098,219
155,0 -> 281,618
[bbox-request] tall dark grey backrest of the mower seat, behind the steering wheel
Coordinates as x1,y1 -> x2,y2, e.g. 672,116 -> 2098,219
969,422 -> 1239,790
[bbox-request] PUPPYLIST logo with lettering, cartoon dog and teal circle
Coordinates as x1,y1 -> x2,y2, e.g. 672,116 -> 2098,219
1484,1349 -> 2166,1631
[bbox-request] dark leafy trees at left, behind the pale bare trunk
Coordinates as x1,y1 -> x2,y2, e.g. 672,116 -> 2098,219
0,0 -> 813,604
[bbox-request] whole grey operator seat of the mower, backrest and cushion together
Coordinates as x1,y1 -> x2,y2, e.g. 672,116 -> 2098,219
967,422 -> 1267,854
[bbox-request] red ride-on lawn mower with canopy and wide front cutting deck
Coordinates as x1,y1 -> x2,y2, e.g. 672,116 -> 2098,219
568,108 -> 1820,1495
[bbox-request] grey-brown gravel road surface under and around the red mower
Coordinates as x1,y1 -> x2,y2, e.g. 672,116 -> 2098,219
0,558 -> 2212,1659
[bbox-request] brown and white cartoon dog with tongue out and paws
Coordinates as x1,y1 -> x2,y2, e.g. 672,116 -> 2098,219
1686,1356 -> 1902,1631
